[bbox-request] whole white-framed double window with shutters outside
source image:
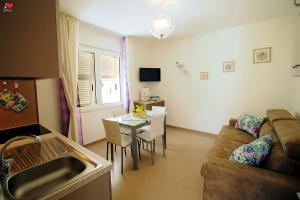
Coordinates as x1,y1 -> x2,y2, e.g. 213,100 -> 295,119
77,46 -> 121,107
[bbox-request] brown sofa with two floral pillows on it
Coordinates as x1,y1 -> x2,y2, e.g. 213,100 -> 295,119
201,109 -> 300,200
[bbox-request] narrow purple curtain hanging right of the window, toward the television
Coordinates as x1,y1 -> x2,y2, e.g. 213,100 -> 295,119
121,37 -> 130,113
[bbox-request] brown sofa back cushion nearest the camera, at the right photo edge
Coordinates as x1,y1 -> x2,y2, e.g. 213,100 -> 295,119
273,120 -> 300,160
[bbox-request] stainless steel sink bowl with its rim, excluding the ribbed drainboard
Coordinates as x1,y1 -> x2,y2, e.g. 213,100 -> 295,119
3,138 -> 101,200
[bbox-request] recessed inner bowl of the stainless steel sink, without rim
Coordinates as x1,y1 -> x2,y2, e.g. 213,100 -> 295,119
7,157 -> 86,199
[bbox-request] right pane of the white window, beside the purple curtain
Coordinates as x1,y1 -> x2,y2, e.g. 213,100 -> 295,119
100,55 -> 121,104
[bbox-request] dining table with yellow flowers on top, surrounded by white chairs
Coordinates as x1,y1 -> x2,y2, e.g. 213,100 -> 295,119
108,111 -> 166,170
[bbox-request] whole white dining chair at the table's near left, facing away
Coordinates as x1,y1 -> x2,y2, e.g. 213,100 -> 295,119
102,119 -> 140,174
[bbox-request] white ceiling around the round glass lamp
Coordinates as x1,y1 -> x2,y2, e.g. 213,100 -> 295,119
60,0 -> 297,38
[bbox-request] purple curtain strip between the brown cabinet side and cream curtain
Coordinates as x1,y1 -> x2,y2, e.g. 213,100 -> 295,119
58,78 -> 70,137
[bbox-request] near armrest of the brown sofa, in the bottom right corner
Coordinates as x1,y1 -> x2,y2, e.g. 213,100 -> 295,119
202,157 -> 300,200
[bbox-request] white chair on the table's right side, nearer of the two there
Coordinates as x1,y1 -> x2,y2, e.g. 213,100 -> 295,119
137,113 -> 165,165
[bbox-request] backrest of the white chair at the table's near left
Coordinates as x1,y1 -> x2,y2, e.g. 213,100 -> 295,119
102,119 -> 122,146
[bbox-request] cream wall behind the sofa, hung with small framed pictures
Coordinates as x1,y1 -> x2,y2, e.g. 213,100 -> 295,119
149,17 -> 299,134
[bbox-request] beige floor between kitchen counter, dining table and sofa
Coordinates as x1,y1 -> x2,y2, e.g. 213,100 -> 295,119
88,128 -> 215,200
